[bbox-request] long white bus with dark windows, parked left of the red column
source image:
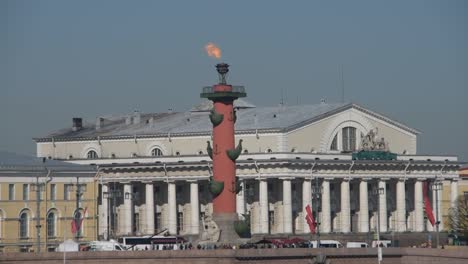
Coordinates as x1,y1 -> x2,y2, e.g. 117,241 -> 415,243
118,236 -> 187,250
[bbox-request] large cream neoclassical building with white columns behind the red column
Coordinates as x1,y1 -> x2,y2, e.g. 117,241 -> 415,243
35,99 -> 461,239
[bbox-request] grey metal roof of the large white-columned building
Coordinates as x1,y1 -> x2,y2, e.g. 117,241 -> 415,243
35,101 -> 419,141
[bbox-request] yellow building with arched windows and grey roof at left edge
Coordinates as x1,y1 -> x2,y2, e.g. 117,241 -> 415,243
0,152 -> 98,252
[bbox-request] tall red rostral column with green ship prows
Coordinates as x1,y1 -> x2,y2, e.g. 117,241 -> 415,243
200,63 -> 246,214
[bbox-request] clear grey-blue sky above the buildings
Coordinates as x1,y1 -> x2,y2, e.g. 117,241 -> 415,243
0,0 -> 468,161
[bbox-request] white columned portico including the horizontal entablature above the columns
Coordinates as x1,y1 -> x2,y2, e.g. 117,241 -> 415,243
100,153 -> 458,235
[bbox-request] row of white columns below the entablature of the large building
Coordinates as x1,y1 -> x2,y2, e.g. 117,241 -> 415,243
100,177 -> 458,235
